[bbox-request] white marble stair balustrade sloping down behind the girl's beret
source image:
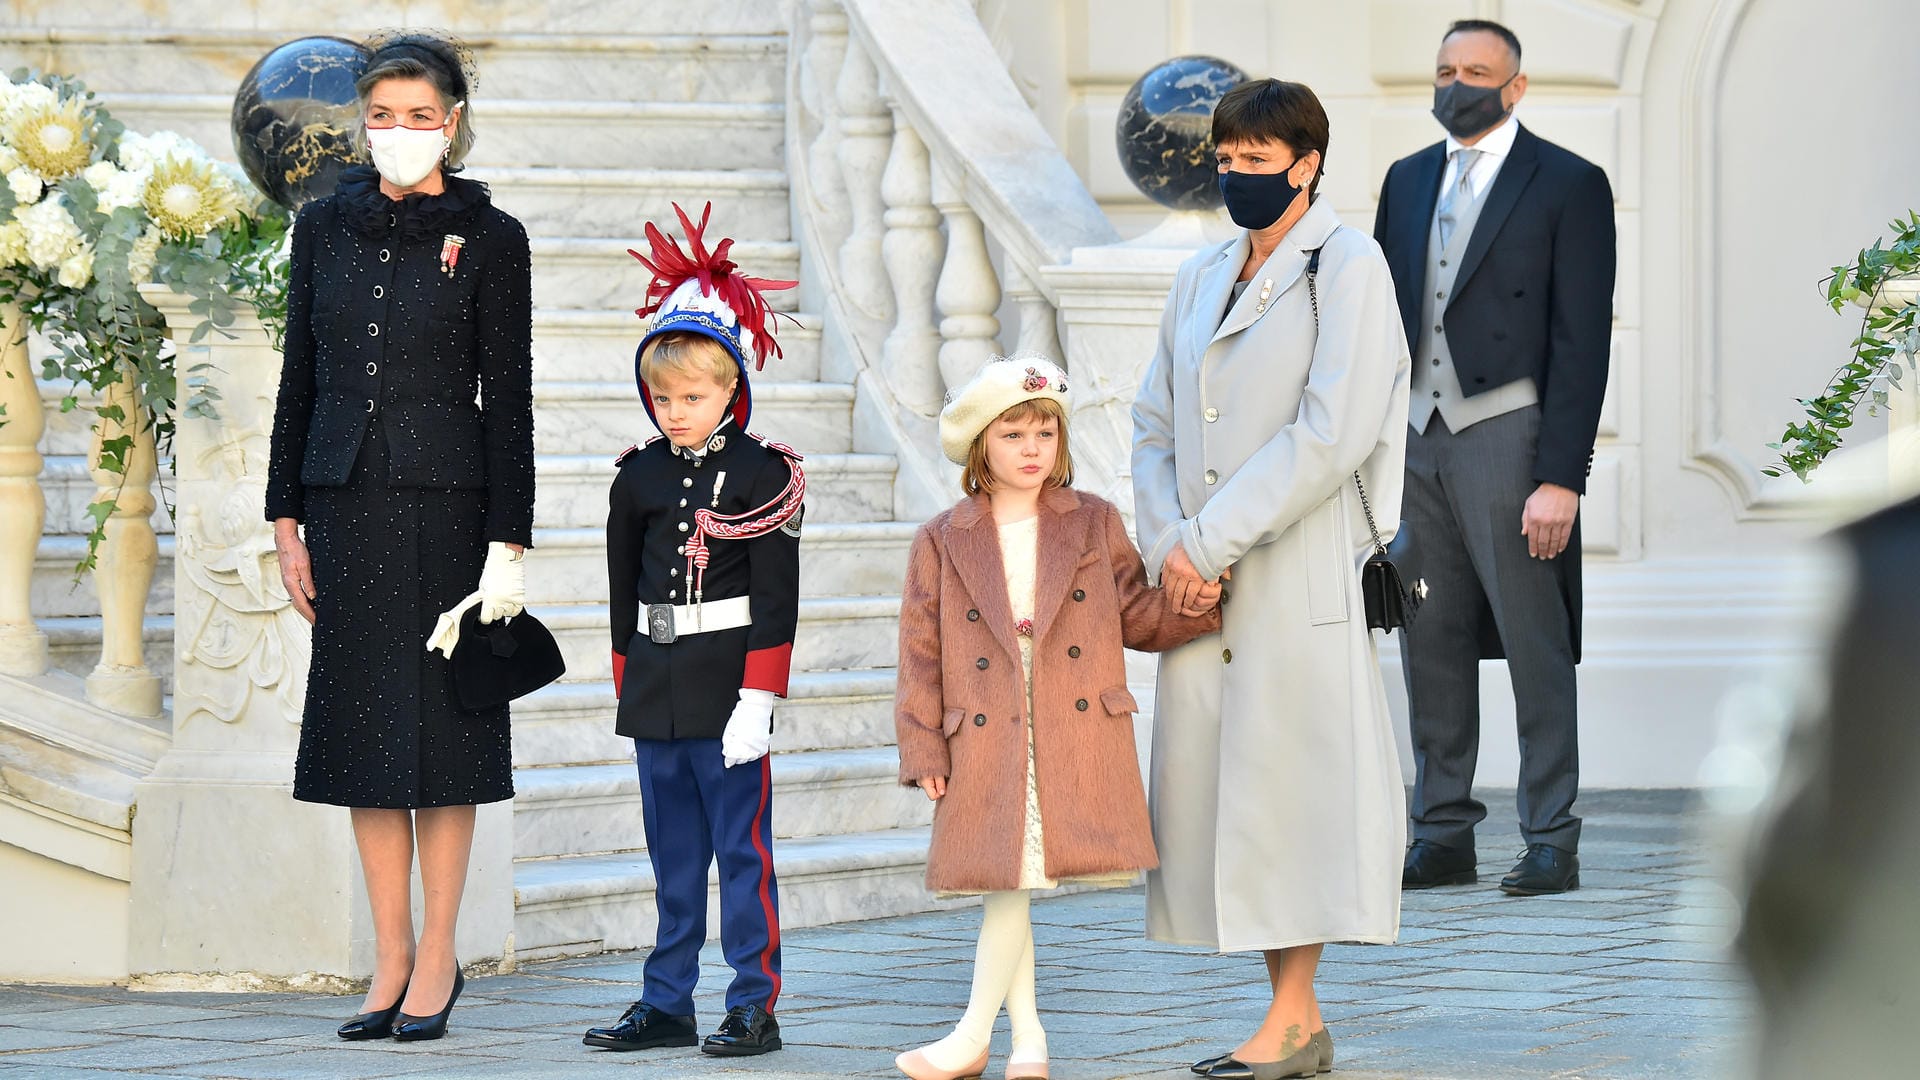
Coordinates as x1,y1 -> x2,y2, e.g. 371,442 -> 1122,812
787,0 -> 1133,517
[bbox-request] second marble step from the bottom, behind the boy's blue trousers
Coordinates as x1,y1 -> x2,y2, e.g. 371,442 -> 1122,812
513,748 -> 933,859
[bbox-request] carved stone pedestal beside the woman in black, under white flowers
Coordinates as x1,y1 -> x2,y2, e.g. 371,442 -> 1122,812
129,286 -> 513,990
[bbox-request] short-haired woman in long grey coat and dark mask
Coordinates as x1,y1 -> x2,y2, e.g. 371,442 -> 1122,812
1133,79 -> 1409,1080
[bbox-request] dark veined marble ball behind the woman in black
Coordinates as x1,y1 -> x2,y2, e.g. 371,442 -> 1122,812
232,37 -> 367,209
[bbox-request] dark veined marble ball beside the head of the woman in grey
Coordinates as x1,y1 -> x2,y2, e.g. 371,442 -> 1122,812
1114,56 -> 1246,209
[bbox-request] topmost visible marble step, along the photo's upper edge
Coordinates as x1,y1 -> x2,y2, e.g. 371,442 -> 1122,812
12,0 -> 787,38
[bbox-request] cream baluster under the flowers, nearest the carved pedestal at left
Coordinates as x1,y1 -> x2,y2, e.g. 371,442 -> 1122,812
86,368 -> 161,717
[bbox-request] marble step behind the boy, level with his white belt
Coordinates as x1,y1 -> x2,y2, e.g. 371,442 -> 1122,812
532,596 -> 900,682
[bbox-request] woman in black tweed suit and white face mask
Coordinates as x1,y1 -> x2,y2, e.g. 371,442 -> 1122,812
267,35 -> 534,1040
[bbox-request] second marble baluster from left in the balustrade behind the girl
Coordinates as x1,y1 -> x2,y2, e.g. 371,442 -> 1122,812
837,38 -> 893,331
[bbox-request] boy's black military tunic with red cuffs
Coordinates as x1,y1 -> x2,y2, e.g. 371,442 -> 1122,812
607,421 -> 801,738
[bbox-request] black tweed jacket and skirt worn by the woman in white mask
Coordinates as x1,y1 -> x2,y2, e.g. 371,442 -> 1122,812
265,167 -> 534,807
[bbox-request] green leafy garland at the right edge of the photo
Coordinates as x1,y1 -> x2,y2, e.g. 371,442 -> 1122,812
1763,211 -> 1920,480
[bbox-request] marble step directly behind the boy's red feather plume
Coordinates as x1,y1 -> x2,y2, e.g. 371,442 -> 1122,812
534,238 -> 801,311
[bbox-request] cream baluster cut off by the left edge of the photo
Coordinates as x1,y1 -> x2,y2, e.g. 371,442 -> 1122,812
0,304 -> 46,678
